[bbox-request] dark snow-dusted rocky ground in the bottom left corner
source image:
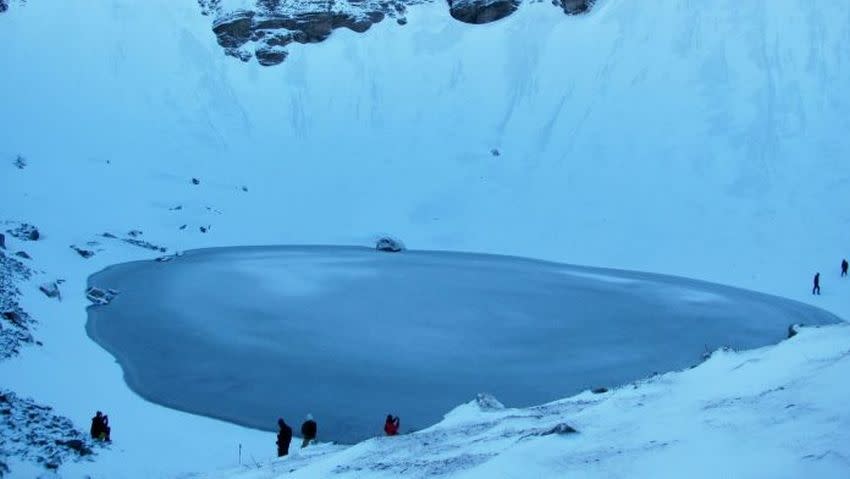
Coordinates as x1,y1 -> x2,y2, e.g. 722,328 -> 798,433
0,390 -> 95,473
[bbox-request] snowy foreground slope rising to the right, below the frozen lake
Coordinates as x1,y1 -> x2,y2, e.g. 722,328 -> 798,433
192,326 -> 850,479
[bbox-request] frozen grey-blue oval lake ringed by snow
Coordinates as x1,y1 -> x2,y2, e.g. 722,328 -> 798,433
87,247 -> 838,442
